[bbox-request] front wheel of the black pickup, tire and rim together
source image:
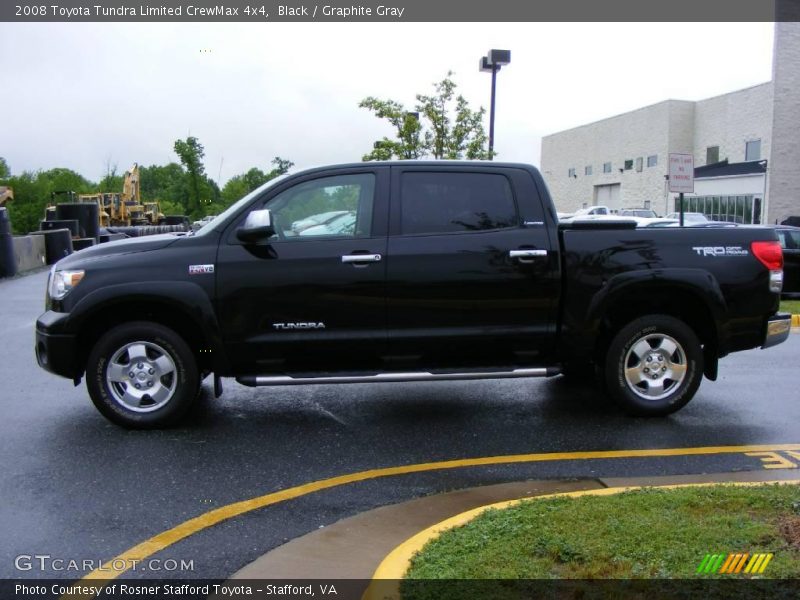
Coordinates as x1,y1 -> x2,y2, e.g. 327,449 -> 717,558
86,321 -> 200,429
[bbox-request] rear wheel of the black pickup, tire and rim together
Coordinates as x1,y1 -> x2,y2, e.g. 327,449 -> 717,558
605,315 -> 703,417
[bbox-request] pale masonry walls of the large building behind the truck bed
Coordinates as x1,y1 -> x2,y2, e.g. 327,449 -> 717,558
541,22 -> 800,222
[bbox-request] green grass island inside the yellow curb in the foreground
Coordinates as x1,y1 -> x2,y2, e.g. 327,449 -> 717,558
406,485 -> 800,583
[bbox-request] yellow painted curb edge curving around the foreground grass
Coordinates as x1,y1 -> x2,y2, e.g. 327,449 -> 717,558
362,479 -> 800,600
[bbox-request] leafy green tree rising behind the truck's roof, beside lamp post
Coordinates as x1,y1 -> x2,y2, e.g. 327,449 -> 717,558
359,71 -> 491,161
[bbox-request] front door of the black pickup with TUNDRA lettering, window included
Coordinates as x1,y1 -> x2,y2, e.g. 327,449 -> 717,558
212,167 -> 389,374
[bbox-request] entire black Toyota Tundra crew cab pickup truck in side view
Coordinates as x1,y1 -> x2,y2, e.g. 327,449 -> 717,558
36,161 -> 790,428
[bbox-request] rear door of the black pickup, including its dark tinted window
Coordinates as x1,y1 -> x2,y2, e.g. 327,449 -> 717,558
387,165 -> 559,367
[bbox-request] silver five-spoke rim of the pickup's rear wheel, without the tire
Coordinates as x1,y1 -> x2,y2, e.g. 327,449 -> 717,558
625,333 -> 687,400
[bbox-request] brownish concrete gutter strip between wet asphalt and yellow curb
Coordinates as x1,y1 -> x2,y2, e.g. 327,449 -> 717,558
231,469 -> 798,581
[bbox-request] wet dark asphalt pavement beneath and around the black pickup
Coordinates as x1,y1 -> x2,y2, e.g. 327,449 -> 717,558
0,272 -> 800,579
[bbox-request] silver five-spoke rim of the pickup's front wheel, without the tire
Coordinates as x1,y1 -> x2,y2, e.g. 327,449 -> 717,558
106,342 -> 178,413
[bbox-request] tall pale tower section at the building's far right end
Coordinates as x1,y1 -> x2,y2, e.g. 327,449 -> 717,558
766,22 -> 800,223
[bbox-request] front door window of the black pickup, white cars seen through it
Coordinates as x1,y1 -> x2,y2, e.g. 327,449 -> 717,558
265,173 -> 375,241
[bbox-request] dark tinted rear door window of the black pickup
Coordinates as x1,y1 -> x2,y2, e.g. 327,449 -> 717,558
400,172 -> 519,235
